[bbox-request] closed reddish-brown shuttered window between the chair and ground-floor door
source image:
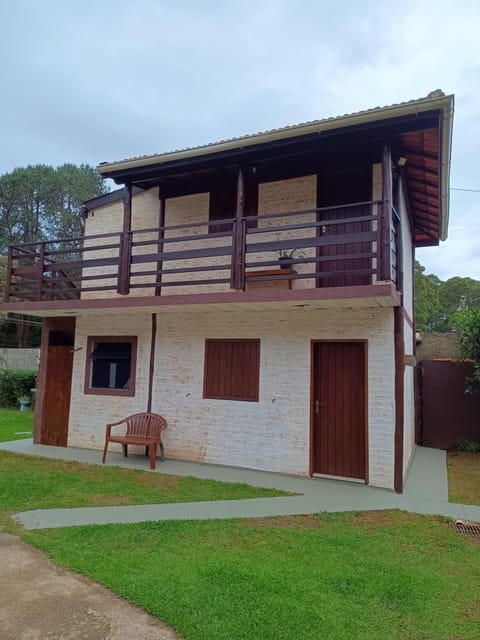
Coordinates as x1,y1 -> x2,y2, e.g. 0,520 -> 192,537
203,339 -> 260,402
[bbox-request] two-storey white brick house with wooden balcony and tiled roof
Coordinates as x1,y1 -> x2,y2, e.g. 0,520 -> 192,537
0,91 -> 453,492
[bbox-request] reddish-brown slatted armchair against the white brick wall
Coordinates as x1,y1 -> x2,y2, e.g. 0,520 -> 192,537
102,413 -> 168,469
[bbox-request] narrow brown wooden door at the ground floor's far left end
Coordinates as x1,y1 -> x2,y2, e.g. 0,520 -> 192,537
40,346 -> 73,447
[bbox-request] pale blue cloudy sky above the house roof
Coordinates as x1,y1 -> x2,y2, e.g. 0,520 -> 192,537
0,0 -> 480,280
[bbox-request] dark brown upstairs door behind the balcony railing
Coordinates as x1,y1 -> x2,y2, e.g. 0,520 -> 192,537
317,167 -> 372,287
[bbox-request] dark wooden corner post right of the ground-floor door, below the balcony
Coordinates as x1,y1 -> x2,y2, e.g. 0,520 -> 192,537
393,307 -> 405,493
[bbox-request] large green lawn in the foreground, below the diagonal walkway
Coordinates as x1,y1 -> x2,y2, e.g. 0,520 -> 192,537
25,512 -> 480,640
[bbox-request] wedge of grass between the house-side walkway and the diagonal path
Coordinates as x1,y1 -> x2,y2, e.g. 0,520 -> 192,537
0,451 -> 288,522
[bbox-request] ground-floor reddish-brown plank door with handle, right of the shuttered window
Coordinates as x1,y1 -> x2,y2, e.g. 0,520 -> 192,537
312,342 -> 366,480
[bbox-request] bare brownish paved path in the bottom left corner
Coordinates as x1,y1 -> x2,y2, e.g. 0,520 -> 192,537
0,533 -> 178,640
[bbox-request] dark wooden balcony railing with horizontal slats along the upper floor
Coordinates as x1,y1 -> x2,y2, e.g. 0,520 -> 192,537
5,201 -> 400,302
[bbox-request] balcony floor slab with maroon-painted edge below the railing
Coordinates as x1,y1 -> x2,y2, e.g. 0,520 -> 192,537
0,282 -> 400,317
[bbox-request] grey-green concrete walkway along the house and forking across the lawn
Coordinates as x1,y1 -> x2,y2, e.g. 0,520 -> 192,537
0,440 -> 480,529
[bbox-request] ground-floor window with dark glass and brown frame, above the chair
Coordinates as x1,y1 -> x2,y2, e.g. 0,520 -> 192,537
85,336 -> 137,396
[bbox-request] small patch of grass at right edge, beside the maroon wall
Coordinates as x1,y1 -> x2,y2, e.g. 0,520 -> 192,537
447,451 -> 480,505
